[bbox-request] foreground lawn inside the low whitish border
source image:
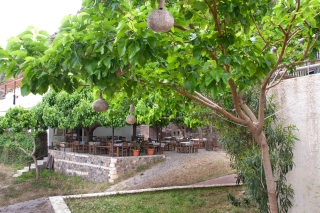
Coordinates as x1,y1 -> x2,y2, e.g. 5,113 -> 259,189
66,186 -> 257,213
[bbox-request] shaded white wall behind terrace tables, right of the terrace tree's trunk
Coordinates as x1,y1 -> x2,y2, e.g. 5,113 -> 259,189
93,125 -> 133,140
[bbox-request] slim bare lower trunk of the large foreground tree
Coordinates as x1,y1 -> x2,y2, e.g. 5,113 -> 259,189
255,132 -> 278,213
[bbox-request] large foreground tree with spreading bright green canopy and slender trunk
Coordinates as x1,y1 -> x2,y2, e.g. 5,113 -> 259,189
0,0 -> 320,212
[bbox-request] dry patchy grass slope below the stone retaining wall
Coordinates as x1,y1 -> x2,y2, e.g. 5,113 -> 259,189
0,165 -> 111,206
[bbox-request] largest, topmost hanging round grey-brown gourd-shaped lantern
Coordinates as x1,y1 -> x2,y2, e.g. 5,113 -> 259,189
147,0 -> 174,32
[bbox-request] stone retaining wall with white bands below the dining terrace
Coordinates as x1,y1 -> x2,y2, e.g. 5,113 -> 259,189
49,150 -> 165,182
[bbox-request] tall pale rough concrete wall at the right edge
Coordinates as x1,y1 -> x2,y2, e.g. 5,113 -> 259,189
269,74 -> 320,213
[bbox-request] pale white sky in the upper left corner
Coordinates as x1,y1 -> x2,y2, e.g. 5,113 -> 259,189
0,0 -> 81,48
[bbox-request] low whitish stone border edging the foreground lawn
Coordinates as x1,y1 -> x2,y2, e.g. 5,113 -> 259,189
49,183 -> 242,213
